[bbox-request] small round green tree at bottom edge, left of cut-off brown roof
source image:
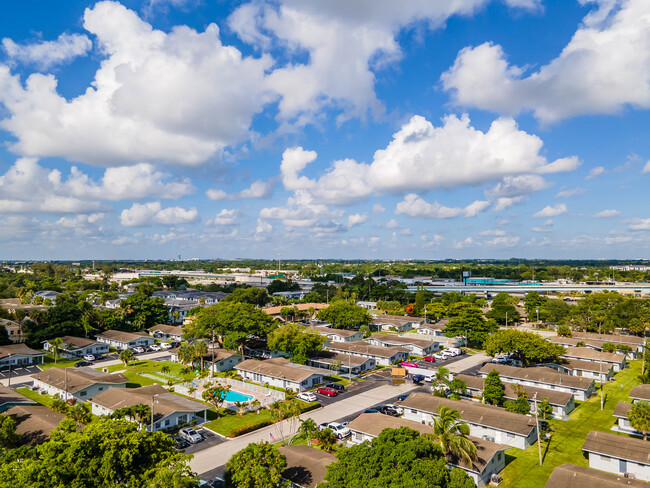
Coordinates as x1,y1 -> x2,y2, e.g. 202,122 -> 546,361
226,442 -> 287,488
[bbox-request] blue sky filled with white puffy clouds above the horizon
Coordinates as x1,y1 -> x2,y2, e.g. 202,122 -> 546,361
0,0 -> 650,259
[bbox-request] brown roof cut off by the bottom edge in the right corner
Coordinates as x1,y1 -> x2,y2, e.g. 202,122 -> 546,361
545,464 -> 648,488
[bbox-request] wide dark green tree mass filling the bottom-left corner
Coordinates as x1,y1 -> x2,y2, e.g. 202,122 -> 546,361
0,418 -> 197,488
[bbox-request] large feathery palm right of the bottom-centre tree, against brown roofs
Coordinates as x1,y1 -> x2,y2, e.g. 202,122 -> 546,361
433,405 -> 476,465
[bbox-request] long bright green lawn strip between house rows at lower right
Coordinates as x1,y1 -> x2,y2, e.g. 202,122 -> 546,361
500,360 -> 641,488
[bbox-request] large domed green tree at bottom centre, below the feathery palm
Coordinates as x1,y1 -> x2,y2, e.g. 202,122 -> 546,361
319,427 -> 471,488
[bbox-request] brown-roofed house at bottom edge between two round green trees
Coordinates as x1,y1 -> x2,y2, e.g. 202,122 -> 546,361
279,445 -> 337,488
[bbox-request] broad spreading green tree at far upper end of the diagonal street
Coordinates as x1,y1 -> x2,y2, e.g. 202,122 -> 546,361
485,330 -> 566,365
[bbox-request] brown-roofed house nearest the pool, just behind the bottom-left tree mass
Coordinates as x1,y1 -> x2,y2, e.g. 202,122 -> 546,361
90,385 -> 210,430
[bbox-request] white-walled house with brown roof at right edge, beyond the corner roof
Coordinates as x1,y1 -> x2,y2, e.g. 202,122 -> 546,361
582,430 -> 650,481
